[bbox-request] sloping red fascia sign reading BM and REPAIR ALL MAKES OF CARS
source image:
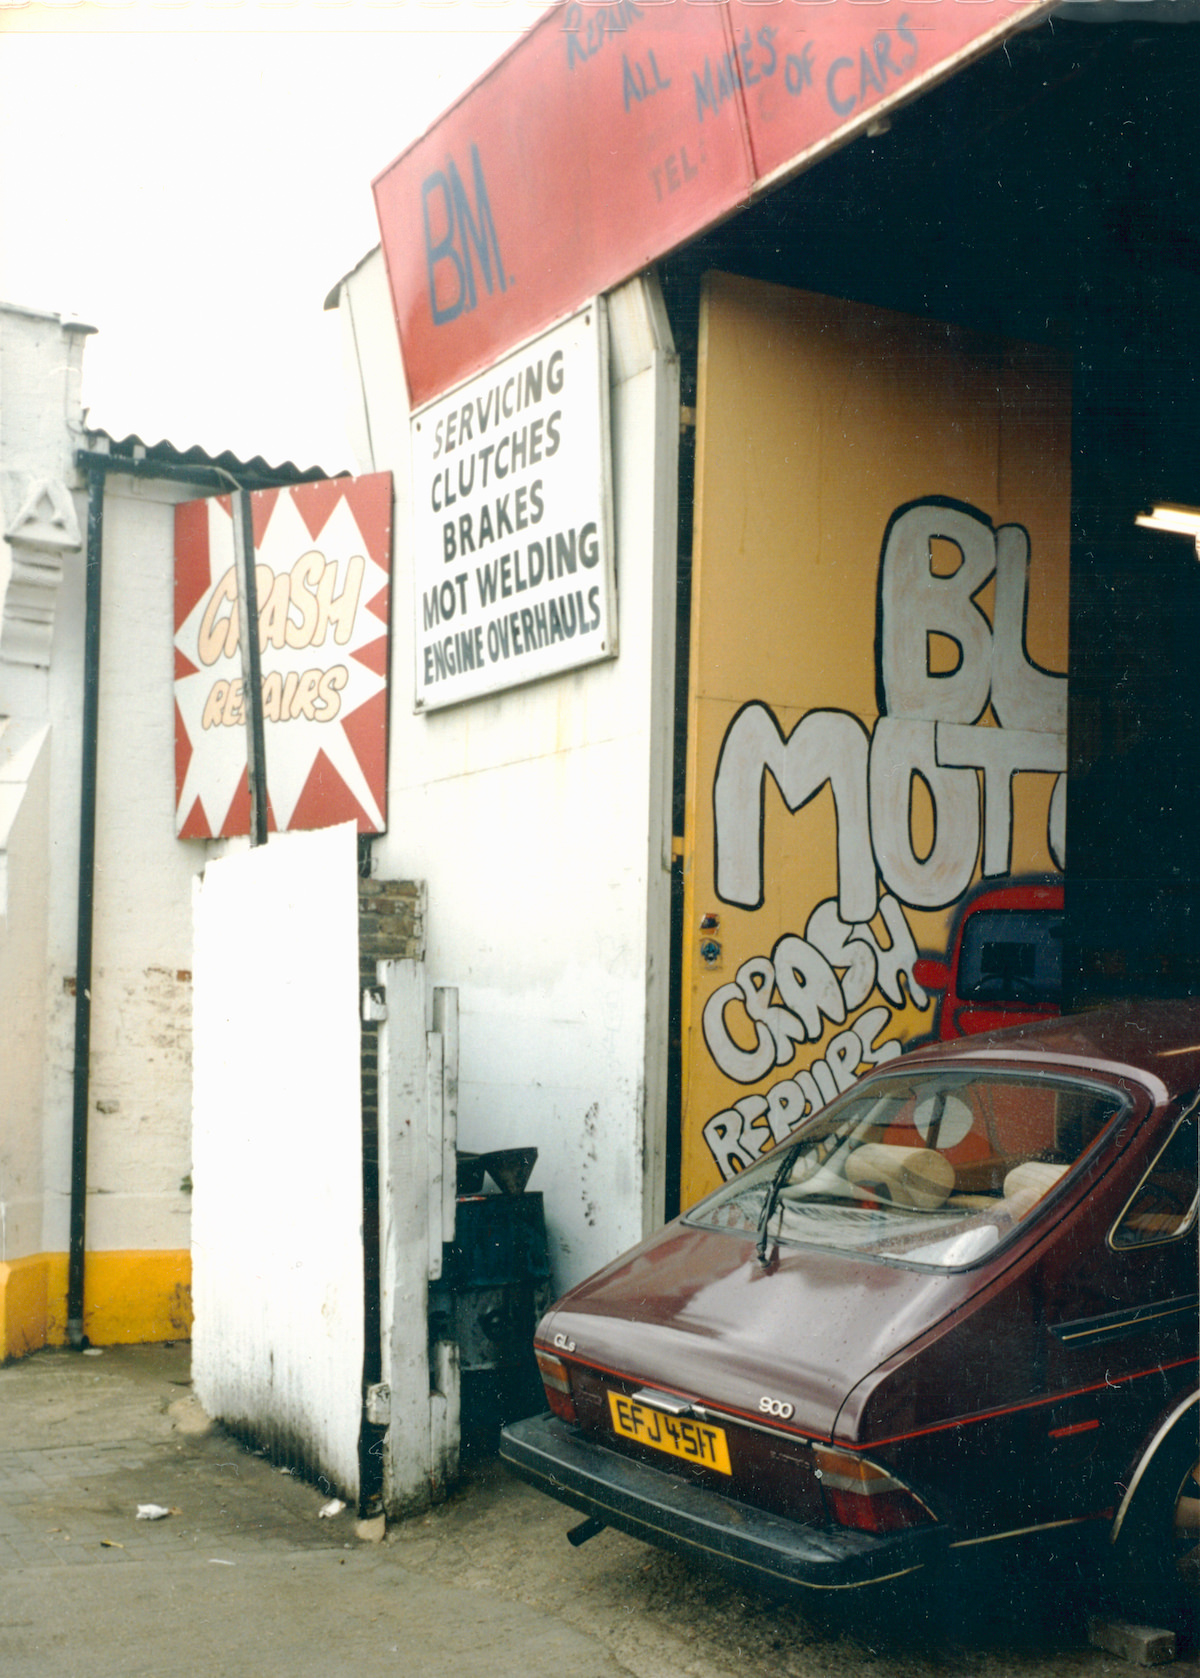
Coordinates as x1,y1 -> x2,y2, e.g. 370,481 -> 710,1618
374,0 -> 1051,406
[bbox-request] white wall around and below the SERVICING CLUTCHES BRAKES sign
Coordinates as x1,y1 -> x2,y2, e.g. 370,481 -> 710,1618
339,252 -> 678,1285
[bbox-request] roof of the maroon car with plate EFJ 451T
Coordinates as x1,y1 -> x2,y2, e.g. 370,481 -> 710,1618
890,1000 -> 1200,1101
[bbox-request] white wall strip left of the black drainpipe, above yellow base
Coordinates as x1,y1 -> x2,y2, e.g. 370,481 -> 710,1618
0,307 -> 84,1259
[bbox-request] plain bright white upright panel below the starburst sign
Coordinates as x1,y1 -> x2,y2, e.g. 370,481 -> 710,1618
191,826 -> 363,1497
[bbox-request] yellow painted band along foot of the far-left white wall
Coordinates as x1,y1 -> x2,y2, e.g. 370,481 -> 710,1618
0,1252 -> 191,1363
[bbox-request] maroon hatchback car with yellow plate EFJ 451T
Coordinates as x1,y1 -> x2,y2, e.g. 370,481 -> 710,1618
502,1003 -> 1200,1617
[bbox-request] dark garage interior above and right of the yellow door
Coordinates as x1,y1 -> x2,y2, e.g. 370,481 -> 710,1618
660,3 -> 1200,1008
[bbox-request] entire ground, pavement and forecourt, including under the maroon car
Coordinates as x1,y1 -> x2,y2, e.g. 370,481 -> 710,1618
0,1346 -> 1200,1678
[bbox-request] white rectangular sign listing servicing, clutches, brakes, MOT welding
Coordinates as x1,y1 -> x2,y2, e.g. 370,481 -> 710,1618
413,300 -> 616,710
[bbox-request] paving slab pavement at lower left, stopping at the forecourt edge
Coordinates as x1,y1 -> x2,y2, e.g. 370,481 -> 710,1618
0,1346 -> 634,1678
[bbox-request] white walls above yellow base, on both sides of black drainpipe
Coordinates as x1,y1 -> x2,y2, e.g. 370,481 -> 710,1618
0,307 -> 203,1259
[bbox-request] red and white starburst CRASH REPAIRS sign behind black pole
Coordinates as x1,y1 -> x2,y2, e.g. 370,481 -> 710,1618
175,472 -> 391,839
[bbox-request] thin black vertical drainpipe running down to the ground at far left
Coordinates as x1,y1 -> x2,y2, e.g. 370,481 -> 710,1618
67,463 -> 104,1351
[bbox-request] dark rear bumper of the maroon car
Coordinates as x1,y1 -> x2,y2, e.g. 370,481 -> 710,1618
500,1415 -> 945,1594
